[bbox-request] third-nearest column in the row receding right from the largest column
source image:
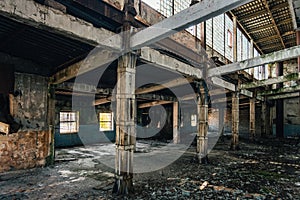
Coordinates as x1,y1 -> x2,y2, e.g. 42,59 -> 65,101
230,92 -> 239,150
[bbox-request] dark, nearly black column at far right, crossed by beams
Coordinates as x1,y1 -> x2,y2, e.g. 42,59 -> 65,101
276,62 -> 284,138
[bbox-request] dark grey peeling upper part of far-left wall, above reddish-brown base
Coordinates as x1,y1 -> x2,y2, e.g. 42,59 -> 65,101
13,73 -> 48,131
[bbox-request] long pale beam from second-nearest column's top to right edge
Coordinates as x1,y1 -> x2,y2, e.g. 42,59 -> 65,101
207,46 -> 300,77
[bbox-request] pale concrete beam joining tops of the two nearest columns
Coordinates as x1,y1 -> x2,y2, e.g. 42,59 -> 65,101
140,47 -> 203,79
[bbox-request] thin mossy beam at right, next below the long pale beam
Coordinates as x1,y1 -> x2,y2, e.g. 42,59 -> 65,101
241,73 -> 300,89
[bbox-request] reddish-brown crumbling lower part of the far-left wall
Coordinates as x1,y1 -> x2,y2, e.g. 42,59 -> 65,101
0,131 -> 51,173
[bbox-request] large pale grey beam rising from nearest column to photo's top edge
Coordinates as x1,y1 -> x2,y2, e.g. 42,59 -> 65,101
131,0 -> 251,49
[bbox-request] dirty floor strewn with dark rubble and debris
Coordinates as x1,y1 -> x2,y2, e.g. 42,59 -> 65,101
0,139 -> 300,200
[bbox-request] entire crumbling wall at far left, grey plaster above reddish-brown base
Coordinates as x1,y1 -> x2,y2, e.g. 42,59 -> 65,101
0,73 -> 51,172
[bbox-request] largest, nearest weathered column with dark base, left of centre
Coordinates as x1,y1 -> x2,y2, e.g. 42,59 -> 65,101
113,53 -> 136,195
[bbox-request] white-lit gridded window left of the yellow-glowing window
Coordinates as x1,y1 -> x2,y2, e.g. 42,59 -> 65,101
59,111 -> 79,134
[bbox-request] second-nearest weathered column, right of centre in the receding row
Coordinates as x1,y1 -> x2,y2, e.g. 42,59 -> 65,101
197,84 -> 208,164
